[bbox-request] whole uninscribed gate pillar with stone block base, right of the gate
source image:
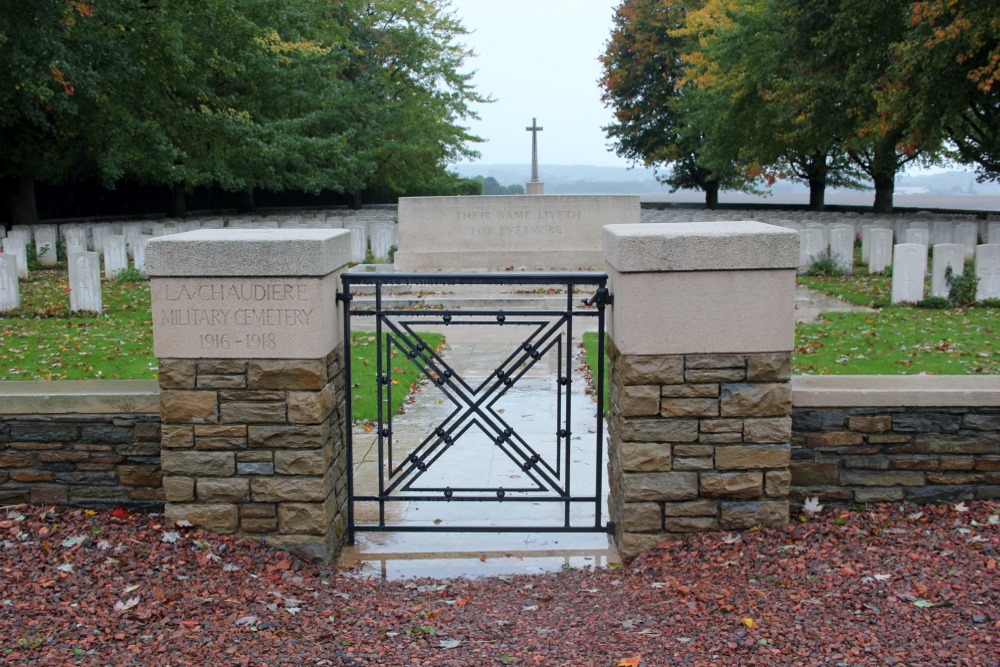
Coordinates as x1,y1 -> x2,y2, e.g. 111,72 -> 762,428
604,222 -> 798,558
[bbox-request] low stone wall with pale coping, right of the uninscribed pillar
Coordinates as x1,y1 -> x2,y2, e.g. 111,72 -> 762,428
790,376 -> 1000,503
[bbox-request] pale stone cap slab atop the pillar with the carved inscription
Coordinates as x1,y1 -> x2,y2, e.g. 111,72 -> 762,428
146,229 -> 351,277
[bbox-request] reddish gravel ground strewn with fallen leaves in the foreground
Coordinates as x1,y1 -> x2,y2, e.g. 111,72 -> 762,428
0,502 -> 1000,667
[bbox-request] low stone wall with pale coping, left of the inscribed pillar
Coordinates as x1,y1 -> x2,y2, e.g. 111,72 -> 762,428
0,381 -> 163,510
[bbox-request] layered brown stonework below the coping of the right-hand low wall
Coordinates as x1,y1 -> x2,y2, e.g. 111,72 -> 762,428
791,407 -> 1000,503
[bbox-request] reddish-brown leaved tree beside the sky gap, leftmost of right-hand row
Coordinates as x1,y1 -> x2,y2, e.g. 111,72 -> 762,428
600,0 -> 746,208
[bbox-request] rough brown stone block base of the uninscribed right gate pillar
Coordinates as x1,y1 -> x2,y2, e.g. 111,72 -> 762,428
607,339 -> 792,557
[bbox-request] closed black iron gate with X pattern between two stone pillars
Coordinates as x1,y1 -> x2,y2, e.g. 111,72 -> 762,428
338,273 -> 610,541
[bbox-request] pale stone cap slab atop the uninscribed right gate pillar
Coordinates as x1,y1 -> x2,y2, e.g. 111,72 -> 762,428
604,220 -> 799,273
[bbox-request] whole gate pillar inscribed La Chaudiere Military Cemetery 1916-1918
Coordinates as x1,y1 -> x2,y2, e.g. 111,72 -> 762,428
146,229 -> 351,561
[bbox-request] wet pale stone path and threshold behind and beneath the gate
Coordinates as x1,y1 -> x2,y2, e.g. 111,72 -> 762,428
340,274 -> 618,576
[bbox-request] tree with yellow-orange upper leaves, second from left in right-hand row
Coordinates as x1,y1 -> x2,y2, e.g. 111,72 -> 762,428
678,0 -> 858,210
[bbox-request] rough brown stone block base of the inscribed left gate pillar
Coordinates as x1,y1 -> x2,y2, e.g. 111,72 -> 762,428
160,346 -> 348,560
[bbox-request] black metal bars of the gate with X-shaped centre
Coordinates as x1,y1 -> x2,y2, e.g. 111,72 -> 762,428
337,273 -> 612,543
